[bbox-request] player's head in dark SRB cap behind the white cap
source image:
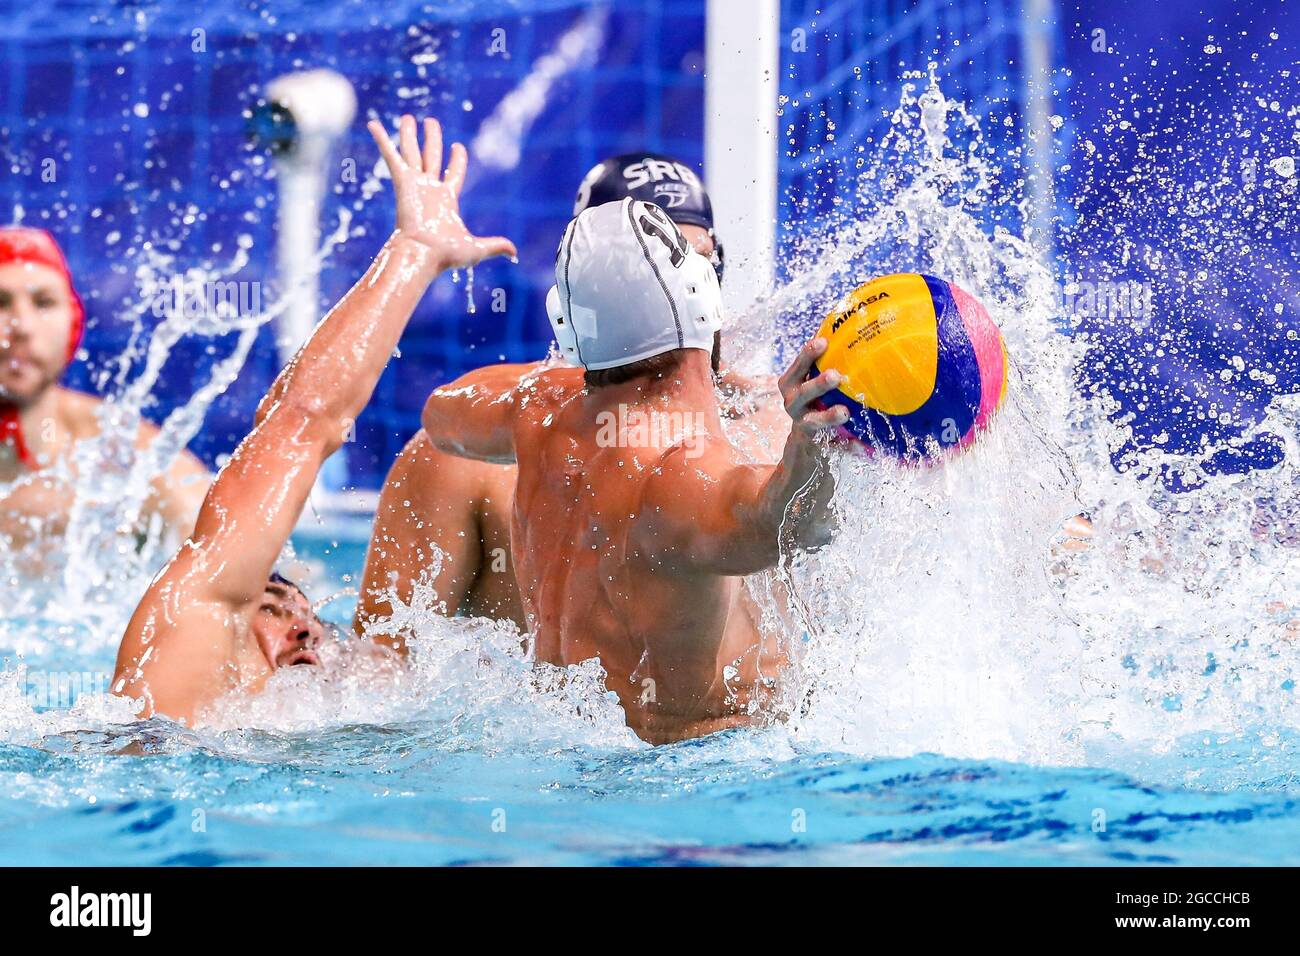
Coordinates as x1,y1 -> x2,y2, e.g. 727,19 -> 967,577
573,152 -> 724,281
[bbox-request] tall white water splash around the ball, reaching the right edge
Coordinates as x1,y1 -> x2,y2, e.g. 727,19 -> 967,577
728,74 -> 1300,780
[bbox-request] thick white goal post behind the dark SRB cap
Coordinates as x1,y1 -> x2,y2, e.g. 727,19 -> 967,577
705,0 -> 781,348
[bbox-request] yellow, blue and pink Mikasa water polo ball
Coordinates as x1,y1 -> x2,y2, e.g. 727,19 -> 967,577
813,272 -> 1008,460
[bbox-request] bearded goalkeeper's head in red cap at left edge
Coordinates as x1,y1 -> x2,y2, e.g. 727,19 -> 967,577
0,226 -> 85,407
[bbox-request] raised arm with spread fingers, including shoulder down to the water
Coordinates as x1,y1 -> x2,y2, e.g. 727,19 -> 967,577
114,116 -> 515,717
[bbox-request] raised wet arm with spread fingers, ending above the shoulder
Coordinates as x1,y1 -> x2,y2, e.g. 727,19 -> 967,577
191,116 -> 515,602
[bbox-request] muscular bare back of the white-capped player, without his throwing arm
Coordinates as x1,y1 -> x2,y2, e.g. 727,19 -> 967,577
441,356 -> 832,743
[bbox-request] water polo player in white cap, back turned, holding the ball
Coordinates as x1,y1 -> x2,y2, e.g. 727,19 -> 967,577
424,198 -> 844,743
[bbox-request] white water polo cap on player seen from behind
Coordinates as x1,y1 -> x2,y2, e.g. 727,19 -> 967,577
546,198 -> 723,369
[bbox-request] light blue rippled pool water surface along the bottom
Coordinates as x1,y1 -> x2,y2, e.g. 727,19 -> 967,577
0,528 -> 1300,865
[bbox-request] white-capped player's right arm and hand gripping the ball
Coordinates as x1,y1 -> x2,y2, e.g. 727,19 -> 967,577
638,339 -> 846,575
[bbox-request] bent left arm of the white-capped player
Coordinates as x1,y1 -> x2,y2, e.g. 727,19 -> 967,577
421,362 -> 546,464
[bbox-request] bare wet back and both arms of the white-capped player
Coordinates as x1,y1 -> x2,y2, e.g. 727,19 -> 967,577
424,343 -> 842,743
